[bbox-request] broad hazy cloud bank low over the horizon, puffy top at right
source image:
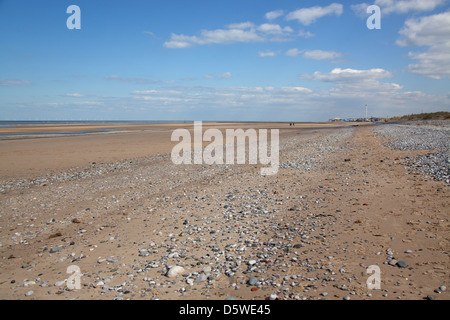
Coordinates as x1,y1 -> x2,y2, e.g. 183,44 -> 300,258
119,80 -> 450,121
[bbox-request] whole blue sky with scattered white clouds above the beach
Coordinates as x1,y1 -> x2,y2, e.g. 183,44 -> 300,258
0,0 -> 450,121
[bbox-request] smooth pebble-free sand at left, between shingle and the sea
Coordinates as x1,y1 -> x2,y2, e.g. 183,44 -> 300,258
0,122 -> 344,178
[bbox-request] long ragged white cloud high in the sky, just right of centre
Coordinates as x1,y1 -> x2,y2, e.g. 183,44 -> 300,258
164,22 -> 295,49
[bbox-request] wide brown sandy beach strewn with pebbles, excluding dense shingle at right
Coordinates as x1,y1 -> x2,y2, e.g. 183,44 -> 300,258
0,122 -> 450,300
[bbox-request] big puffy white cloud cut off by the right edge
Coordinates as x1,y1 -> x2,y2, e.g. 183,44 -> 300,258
396,11 -> 450,79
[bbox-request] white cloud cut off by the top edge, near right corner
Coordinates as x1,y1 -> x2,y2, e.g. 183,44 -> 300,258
350,0 -> 446,17
